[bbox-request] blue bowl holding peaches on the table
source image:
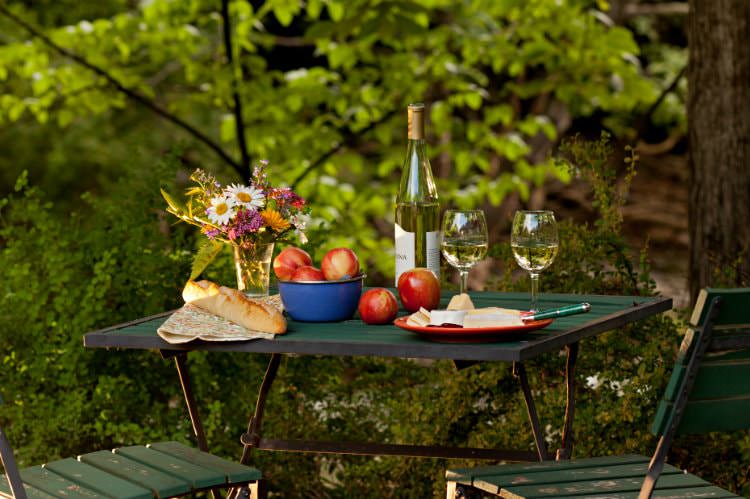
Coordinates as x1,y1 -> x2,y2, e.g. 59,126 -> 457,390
278,274 -> 366,322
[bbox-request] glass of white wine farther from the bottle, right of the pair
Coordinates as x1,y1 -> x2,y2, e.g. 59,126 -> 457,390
510,211 -> 558,312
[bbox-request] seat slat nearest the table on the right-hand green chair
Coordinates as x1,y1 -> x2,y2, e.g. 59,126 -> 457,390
445,454 -> 650,485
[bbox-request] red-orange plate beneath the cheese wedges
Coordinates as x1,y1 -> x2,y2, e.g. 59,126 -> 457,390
393,316 -> 553,343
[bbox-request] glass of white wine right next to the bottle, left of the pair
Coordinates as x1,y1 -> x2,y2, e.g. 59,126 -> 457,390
440,210 -> 488,293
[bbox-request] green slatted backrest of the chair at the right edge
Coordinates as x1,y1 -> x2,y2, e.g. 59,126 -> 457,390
651,288 -> 750,436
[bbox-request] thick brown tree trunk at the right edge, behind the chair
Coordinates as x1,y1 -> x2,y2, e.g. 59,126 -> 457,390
688,0 -> 750,302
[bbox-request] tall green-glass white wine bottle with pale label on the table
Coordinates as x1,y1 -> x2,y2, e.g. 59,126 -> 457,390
395,104 -> 440,283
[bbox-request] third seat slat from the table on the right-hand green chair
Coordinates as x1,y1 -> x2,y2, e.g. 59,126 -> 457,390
496,473 -> 710,499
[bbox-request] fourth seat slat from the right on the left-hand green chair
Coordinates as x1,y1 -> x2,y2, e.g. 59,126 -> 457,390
43,458 -> 153,499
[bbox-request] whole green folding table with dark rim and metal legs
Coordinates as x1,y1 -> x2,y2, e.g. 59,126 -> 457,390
84,293 -> 672,464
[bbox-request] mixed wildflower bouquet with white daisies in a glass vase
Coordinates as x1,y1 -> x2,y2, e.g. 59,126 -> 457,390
161,161 -> 310,296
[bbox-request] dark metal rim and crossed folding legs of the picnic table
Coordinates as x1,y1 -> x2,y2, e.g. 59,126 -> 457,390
84,293 -> 672,494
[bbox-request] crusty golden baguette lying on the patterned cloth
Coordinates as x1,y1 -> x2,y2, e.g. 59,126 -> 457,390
182,280 -> 286,334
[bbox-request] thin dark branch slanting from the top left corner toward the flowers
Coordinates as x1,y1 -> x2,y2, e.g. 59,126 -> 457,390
0,3 -> 243,176
